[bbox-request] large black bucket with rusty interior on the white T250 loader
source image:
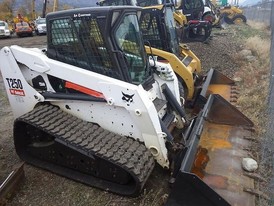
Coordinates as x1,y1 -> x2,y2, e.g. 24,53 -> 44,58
166,94 -> 255,206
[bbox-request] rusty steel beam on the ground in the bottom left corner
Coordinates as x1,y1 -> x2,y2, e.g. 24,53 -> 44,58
0,163 -> 25,206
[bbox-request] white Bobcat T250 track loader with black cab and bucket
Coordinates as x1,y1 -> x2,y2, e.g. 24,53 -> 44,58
0,6 -> 253,206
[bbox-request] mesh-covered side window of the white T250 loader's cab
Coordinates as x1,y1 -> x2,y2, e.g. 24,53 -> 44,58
48,17 -> 120,79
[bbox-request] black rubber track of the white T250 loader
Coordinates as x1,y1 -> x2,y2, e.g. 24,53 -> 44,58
14,105 -> 154,196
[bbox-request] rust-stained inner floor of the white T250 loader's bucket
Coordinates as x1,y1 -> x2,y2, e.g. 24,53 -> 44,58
192,122 -> 255,206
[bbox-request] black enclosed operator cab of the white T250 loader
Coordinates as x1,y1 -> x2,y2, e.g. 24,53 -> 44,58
47,7 -> 149,85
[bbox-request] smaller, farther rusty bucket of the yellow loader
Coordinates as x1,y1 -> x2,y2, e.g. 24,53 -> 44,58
194,69 -> 237,108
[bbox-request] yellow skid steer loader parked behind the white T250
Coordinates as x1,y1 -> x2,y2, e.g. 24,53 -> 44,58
98,0 -> 236,107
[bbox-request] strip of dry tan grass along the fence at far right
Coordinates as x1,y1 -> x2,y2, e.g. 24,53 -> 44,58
231,24 -> 274,206
